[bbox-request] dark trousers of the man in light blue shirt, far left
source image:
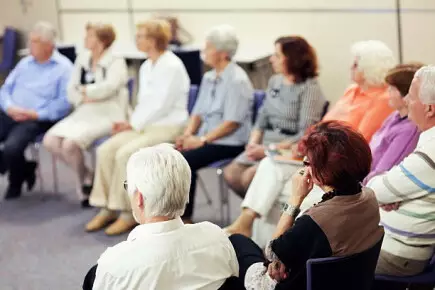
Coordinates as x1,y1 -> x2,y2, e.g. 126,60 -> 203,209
0,110 -> 54,186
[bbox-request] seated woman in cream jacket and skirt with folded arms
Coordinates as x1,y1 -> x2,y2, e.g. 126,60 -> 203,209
43,23 -> 128,207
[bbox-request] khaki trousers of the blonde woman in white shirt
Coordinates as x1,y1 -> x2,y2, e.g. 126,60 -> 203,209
89,126 -> 184,211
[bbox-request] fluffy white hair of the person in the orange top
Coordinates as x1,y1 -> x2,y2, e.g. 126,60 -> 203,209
351,40 -> 396,86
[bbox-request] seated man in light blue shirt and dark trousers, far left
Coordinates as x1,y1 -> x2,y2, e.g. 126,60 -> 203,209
0,22 -> 72,199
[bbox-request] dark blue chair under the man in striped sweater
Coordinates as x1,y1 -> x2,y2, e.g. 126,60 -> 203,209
373,255 -> 435,290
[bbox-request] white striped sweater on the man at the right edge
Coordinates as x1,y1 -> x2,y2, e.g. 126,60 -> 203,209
368,127 -> 435,261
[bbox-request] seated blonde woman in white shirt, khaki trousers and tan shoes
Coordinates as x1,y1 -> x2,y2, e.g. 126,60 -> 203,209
86,19 -> 190,235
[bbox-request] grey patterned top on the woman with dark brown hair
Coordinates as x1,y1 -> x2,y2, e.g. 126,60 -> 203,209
255,75 -> 326,142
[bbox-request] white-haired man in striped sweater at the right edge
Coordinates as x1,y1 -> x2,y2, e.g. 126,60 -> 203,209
367,66 -> 435,276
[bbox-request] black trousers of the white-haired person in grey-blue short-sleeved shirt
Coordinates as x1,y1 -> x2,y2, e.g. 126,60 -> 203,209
183,144 -> 245,218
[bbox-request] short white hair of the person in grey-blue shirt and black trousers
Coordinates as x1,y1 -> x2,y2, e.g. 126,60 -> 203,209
205,24 -> 239,59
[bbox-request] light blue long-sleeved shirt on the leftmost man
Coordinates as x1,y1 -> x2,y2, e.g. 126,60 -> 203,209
0,51 -> 73,121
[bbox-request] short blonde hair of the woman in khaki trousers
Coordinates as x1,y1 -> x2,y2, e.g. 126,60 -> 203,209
136,18 -> 172,51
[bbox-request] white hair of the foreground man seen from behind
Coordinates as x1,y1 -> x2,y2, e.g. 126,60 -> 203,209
127,144 -> 191,218
